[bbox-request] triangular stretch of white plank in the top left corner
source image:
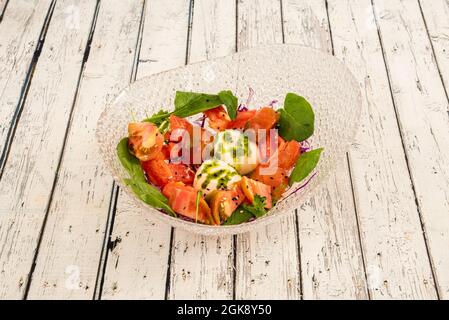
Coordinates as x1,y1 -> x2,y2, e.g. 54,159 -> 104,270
0,0 -> 51,165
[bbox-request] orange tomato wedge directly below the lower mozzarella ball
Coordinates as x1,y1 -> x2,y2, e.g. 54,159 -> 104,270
210,184 -> 245,224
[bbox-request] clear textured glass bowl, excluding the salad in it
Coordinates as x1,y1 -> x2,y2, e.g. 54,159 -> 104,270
96,45 -> 361,235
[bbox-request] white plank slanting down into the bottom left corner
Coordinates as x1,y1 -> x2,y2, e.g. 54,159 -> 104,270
0,0 -> 95,298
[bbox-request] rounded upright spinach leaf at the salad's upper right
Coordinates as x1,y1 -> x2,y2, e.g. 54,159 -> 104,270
279,93 -> 315,141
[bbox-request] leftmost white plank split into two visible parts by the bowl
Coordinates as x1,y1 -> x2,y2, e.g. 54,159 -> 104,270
101,0 -> 190,299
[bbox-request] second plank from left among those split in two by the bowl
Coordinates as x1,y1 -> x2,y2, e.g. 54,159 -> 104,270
168,0 -> 236,299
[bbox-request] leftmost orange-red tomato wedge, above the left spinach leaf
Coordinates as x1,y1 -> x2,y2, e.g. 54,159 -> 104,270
128,122 -> 164,161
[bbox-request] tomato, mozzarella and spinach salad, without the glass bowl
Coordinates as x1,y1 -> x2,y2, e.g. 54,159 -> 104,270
117,90 -> 323,226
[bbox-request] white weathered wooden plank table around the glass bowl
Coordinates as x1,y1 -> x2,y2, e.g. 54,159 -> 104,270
0,0 -> 449,299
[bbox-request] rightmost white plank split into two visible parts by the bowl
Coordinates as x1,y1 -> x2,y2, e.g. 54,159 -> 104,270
282,0 -> 368,299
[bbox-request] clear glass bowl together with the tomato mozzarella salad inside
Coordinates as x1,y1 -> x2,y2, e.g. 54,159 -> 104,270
96,45 -> 362,235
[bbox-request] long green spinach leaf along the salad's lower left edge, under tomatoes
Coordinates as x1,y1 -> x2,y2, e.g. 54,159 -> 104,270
117,138 -> 176,217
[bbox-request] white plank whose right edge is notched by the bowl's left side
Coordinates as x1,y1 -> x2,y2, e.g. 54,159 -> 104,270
25,0 -> 143,299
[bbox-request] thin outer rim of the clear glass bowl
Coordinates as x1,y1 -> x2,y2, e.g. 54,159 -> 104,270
95,44 -> 362,236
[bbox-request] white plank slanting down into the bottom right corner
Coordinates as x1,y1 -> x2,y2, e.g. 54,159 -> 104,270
374,0 -> 449,298
